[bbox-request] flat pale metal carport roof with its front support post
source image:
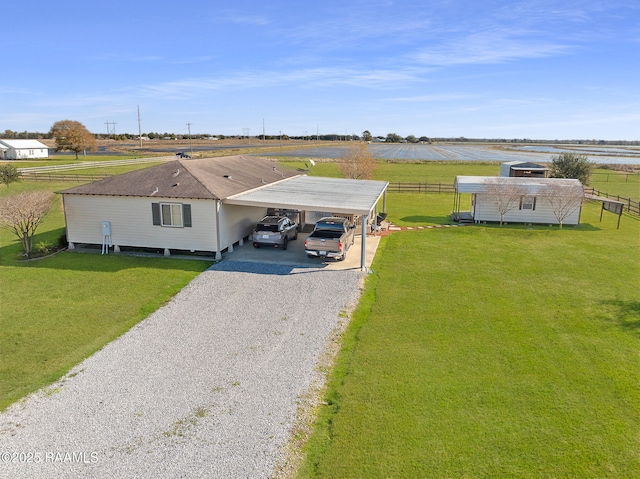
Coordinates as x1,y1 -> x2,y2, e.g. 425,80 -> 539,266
223,175 -> 389,270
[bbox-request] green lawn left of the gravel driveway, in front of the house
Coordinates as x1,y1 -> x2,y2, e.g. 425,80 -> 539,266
0,178 -> 210,410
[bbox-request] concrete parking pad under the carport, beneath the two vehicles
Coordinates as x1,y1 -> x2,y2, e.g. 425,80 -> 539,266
223,233 -> 380,271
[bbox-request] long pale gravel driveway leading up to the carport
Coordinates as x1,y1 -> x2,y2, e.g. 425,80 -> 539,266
0,261 -> 362,478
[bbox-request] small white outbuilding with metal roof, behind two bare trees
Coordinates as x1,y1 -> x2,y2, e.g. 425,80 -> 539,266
452,176 -> 584,225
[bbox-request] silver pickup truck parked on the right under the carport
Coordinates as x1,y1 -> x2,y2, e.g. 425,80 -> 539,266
304,217 -> 356,261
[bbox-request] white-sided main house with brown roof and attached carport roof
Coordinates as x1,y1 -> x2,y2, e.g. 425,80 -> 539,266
61,156 -> 388,266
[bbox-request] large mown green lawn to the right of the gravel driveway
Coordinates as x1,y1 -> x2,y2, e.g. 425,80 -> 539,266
299,200 -> 640,478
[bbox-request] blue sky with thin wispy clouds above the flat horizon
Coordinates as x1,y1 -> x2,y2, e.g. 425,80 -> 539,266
0,0 -> 640,140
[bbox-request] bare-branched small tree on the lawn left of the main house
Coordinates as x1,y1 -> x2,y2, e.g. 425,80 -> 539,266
0,191 -> 53,256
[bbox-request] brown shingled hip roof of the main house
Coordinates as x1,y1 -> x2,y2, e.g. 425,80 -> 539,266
62,156 -> 299,199
